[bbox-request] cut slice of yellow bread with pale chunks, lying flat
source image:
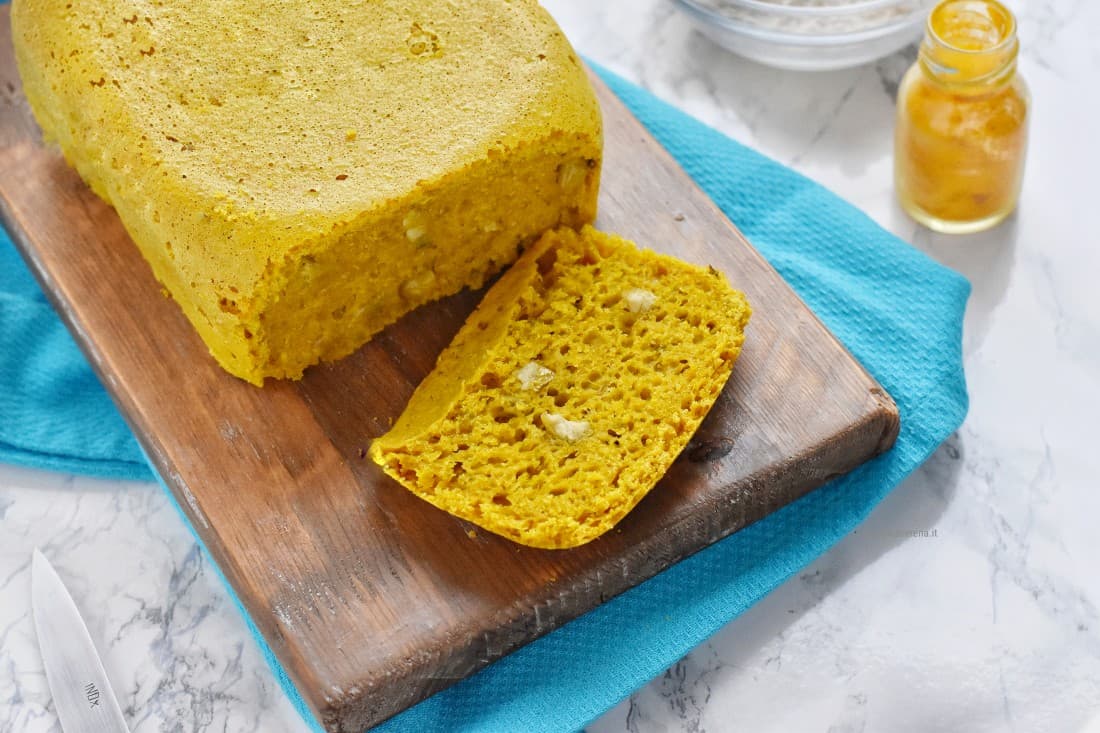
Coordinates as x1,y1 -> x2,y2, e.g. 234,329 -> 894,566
371,227 -> 750,548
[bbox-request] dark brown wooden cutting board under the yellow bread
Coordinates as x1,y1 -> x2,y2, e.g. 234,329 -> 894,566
0,8 -> 898,733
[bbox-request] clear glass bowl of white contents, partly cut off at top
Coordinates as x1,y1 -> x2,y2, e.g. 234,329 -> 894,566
672,0 -> 935,72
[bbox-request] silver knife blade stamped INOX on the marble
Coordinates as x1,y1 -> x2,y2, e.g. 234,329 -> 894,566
31,549 -> 130,733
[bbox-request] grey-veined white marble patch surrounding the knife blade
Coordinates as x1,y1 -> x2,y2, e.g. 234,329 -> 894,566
0,467 -> 304,733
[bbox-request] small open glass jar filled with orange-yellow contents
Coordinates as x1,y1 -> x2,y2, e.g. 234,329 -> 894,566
894,0 -> 1030,233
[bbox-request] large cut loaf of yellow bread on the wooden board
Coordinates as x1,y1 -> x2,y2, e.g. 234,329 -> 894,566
12,0 -> 602,384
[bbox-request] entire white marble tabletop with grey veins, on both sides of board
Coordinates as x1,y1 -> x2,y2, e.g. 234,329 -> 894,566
0,0 -> 1100,733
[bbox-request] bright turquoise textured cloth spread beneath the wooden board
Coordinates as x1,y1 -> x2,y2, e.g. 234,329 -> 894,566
0,65 -> 969,733
